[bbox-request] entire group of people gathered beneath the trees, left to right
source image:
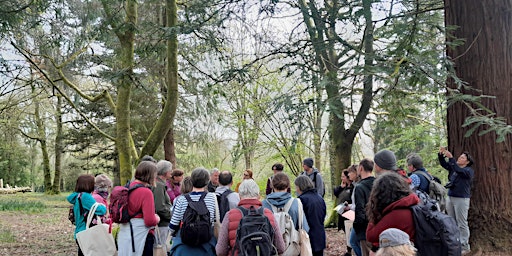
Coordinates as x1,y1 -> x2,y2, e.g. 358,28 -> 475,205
67,148 -> 474,256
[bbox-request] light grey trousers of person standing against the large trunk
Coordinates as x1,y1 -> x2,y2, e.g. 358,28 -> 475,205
446,196 -> 470,250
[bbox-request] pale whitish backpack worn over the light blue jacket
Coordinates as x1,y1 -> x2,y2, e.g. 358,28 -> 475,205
267,198 -> 301,256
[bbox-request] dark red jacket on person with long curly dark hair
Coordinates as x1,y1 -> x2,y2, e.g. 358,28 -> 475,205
366,193 -> 420,247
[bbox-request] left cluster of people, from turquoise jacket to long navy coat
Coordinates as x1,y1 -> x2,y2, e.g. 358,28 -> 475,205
67,157 -> 326,256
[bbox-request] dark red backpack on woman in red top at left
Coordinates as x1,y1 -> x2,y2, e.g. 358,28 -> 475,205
108,183 -> 145,223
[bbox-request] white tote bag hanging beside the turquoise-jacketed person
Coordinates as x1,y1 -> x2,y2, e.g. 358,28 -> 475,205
76,203 -> 116,256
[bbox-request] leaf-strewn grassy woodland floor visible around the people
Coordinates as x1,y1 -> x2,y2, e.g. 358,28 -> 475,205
0,193 -> 506,256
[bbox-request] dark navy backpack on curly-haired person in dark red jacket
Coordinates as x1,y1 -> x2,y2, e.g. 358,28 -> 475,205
411,204 -> 462,256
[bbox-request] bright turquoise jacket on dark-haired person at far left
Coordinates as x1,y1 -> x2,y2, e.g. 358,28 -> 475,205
66,192 -> 107,239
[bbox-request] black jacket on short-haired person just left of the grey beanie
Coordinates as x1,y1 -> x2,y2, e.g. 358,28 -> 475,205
352,176 -> 375,240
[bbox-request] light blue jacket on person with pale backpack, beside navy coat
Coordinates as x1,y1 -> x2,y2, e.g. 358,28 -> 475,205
261,192 -> 309,232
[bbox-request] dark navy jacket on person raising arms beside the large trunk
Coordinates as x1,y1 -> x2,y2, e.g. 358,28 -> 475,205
437,154 -> 475,198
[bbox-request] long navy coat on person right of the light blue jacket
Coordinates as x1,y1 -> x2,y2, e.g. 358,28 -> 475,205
299,189 -> 326,252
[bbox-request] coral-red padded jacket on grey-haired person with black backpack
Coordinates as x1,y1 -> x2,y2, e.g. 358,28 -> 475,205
215,199 -> 285,256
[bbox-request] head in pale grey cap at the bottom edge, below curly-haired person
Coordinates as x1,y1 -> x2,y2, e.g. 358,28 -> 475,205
375,228 -> 416,256
